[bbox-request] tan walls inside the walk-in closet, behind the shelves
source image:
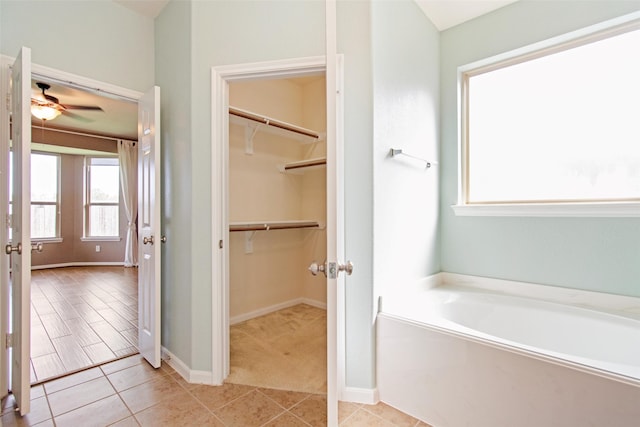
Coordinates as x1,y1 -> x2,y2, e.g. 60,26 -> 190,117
229,79 -> 326,318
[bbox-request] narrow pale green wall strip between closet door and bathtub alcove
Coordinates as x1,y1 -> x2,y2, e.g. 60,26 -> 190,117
336,0 -> 375,389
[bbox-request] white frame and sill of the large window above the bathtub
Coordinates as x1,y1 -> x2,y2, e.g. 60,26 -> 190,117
452,12 -> 640,217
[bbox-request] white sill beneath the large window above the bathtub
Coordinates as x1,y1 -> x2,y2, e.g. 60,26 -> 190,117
451,202 -> 640,218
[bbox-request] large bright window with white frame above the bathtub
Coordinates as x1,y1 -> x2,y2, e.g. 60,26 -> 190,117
453,14 -> 640,216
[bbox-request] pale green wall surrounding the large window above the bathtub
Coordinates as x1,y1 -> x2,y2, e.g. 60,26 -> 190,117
440,0 -> 640,296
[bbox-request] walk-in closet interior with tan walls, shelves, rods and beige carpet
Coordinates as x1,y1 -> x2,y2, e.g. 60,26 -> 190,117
227,75 -> 327,393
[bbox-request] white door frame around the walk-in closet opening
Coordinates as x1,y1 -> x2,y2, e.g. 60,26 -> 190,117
211,55 -> 345,396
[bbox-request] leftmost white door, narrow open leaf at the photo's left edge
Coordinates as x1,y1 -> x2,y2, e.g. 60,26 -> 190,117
5,47 -> 31,415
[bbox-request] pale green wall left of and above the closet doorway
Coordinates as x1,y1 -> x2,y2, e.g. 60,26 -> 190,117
156,0 -> 324,371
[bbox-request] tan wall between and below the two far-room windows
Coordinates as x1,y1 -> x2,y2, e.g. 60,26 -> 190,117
31,150 -> 127,267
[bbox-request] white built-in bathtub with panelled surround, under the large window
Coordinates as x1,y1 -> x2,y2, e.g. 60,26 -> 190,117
377,275 -> 640,427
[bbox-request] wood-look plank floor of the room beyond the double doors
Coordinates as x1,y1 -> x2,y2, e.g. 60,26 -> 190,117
31,267 -> 138,384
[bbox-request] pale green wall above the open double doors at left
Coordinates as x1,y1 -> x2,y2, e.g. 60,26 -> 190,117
0,0 -> 154,91
